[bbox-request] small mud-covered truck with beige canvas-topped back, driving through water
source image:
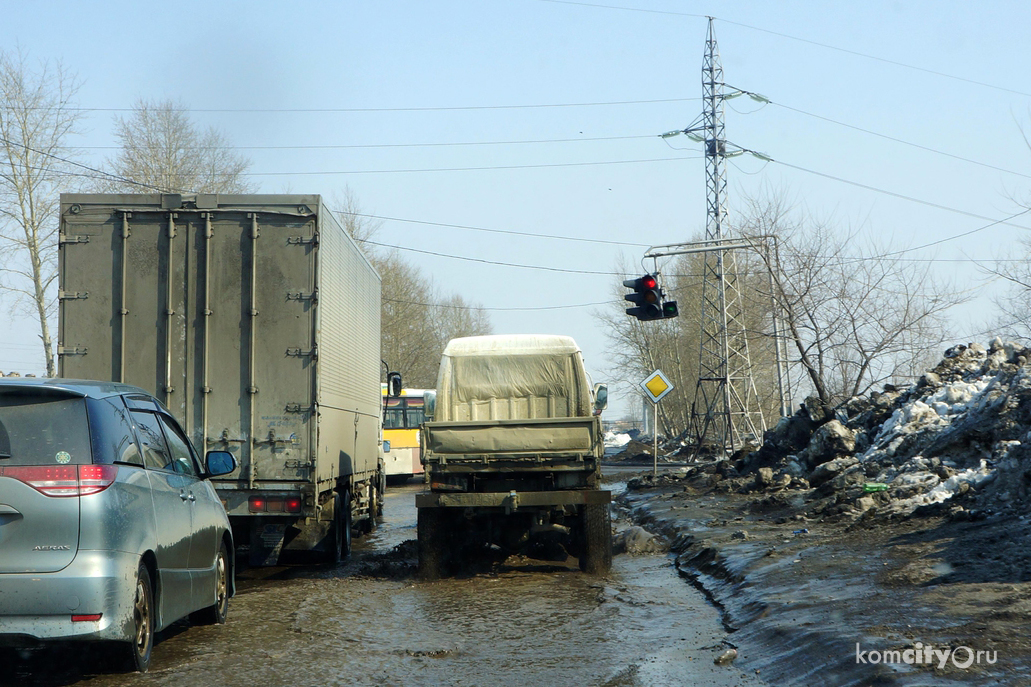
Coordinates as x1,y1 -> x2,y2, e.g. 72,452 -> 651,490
415,334 -> 612,580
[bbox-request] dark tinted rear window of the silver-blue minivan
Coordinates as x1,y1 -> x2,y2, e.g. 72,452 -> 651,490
0,393 -> 92,467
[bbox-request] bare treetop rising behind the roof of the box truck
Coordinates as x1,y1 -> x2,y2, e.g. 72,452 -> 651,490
98,99 -> 256,193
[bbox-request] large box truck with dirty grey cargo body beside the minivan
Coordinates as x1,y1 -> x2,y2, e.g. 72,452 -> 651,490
58,194 -> 391,565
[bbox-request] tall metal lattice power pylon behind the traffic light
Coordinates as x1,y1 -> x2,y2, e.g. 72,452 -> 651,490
691,18 -> 766,453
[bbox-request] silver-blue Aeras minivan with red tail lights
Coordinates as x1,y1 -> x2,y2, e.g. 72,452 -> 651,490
0,378 -> 236,670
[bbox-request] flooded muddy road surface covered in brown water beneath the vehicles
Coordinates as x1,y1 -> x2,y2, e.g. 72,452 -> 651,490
6,478 -> 761,687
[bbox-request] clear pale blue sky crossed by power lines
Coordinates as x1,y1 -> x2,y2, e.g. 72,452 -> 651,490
0,0 -> 1031,408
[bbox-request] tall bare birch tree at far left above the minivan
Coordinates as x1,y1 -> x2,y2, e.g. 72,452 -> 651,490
0,52 -> 81,377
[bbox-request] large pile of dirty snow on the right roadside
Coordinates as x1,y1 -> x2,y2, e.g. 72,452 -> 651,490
641,338 -> 1031,520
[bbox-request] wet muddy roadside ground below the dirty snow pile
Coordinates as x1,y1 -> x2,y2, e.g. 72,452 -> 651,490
621,476 -> 1031,685
